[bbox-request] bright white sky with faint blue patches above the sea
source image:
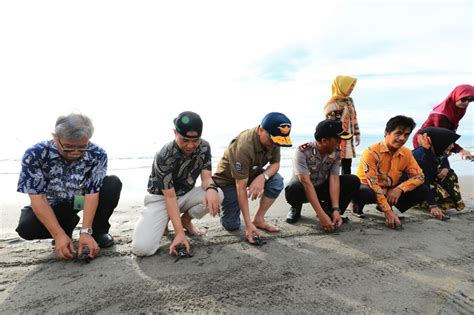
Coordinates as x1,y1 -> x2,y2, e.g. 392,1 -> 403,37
0,0 -> 474,158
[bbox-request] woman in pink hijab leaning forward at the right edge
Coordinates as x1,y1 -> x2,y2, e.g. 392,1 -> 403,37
413,84 -> 474,160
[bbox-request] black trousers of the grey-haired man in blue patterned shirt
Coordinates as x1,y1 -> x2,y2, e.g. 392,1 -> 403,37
16,175 -> 122,240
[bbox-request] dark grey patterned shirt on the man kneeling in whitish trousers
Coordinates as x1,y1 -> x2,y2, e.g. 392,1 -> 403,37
148,140 -> 212,196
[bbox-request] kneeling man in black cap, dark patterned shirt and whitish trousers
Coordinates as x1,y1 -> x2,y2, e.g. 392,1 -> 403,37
132,111 -> 223,256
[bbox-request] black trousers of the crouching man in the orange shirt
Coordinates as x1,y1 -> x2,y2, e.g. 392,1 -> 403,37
353,184 -> 430,212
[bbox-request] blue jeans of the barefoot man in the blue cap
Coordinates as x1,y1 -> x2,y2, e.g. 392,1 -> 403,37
220,173 -> 285,231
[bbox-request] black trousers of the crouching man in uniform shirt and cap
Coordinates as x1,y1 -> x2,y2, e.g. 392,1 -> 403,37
285,175 -> 360,216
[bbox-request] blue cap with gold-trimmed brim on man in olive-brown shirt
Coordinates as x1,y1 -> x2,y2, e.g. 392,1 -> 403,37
260,112 -> 291,147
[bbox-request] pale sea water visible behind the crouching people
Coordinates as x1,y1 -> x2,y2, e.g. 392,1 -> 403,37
0,134 -> 474,202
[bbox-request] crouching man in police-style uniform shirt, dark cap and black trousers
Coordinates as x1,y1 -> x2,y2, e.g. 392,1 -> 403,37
285,120 -> 360,232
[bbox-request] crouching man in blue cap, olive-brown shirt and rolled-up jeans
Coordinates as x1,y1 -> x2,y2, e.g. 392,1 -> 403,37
213,112 -> 291,244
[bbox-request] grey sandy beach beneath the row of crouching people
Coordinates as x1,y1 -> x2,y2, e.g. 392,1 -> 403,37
0,177 -> 474,314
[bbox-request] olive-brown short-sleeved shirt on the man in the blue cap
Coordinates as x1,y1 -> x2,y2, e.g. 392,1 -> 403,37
212,127 -> 280,187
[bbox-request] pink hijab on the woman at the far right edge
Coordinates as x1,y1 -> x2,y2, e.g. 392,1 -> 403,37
430,84 -> 474,129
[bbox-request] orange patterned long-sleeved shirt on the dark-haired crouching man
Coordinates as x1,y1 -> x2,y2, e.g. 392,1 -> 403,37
357,141 -> 425,212
